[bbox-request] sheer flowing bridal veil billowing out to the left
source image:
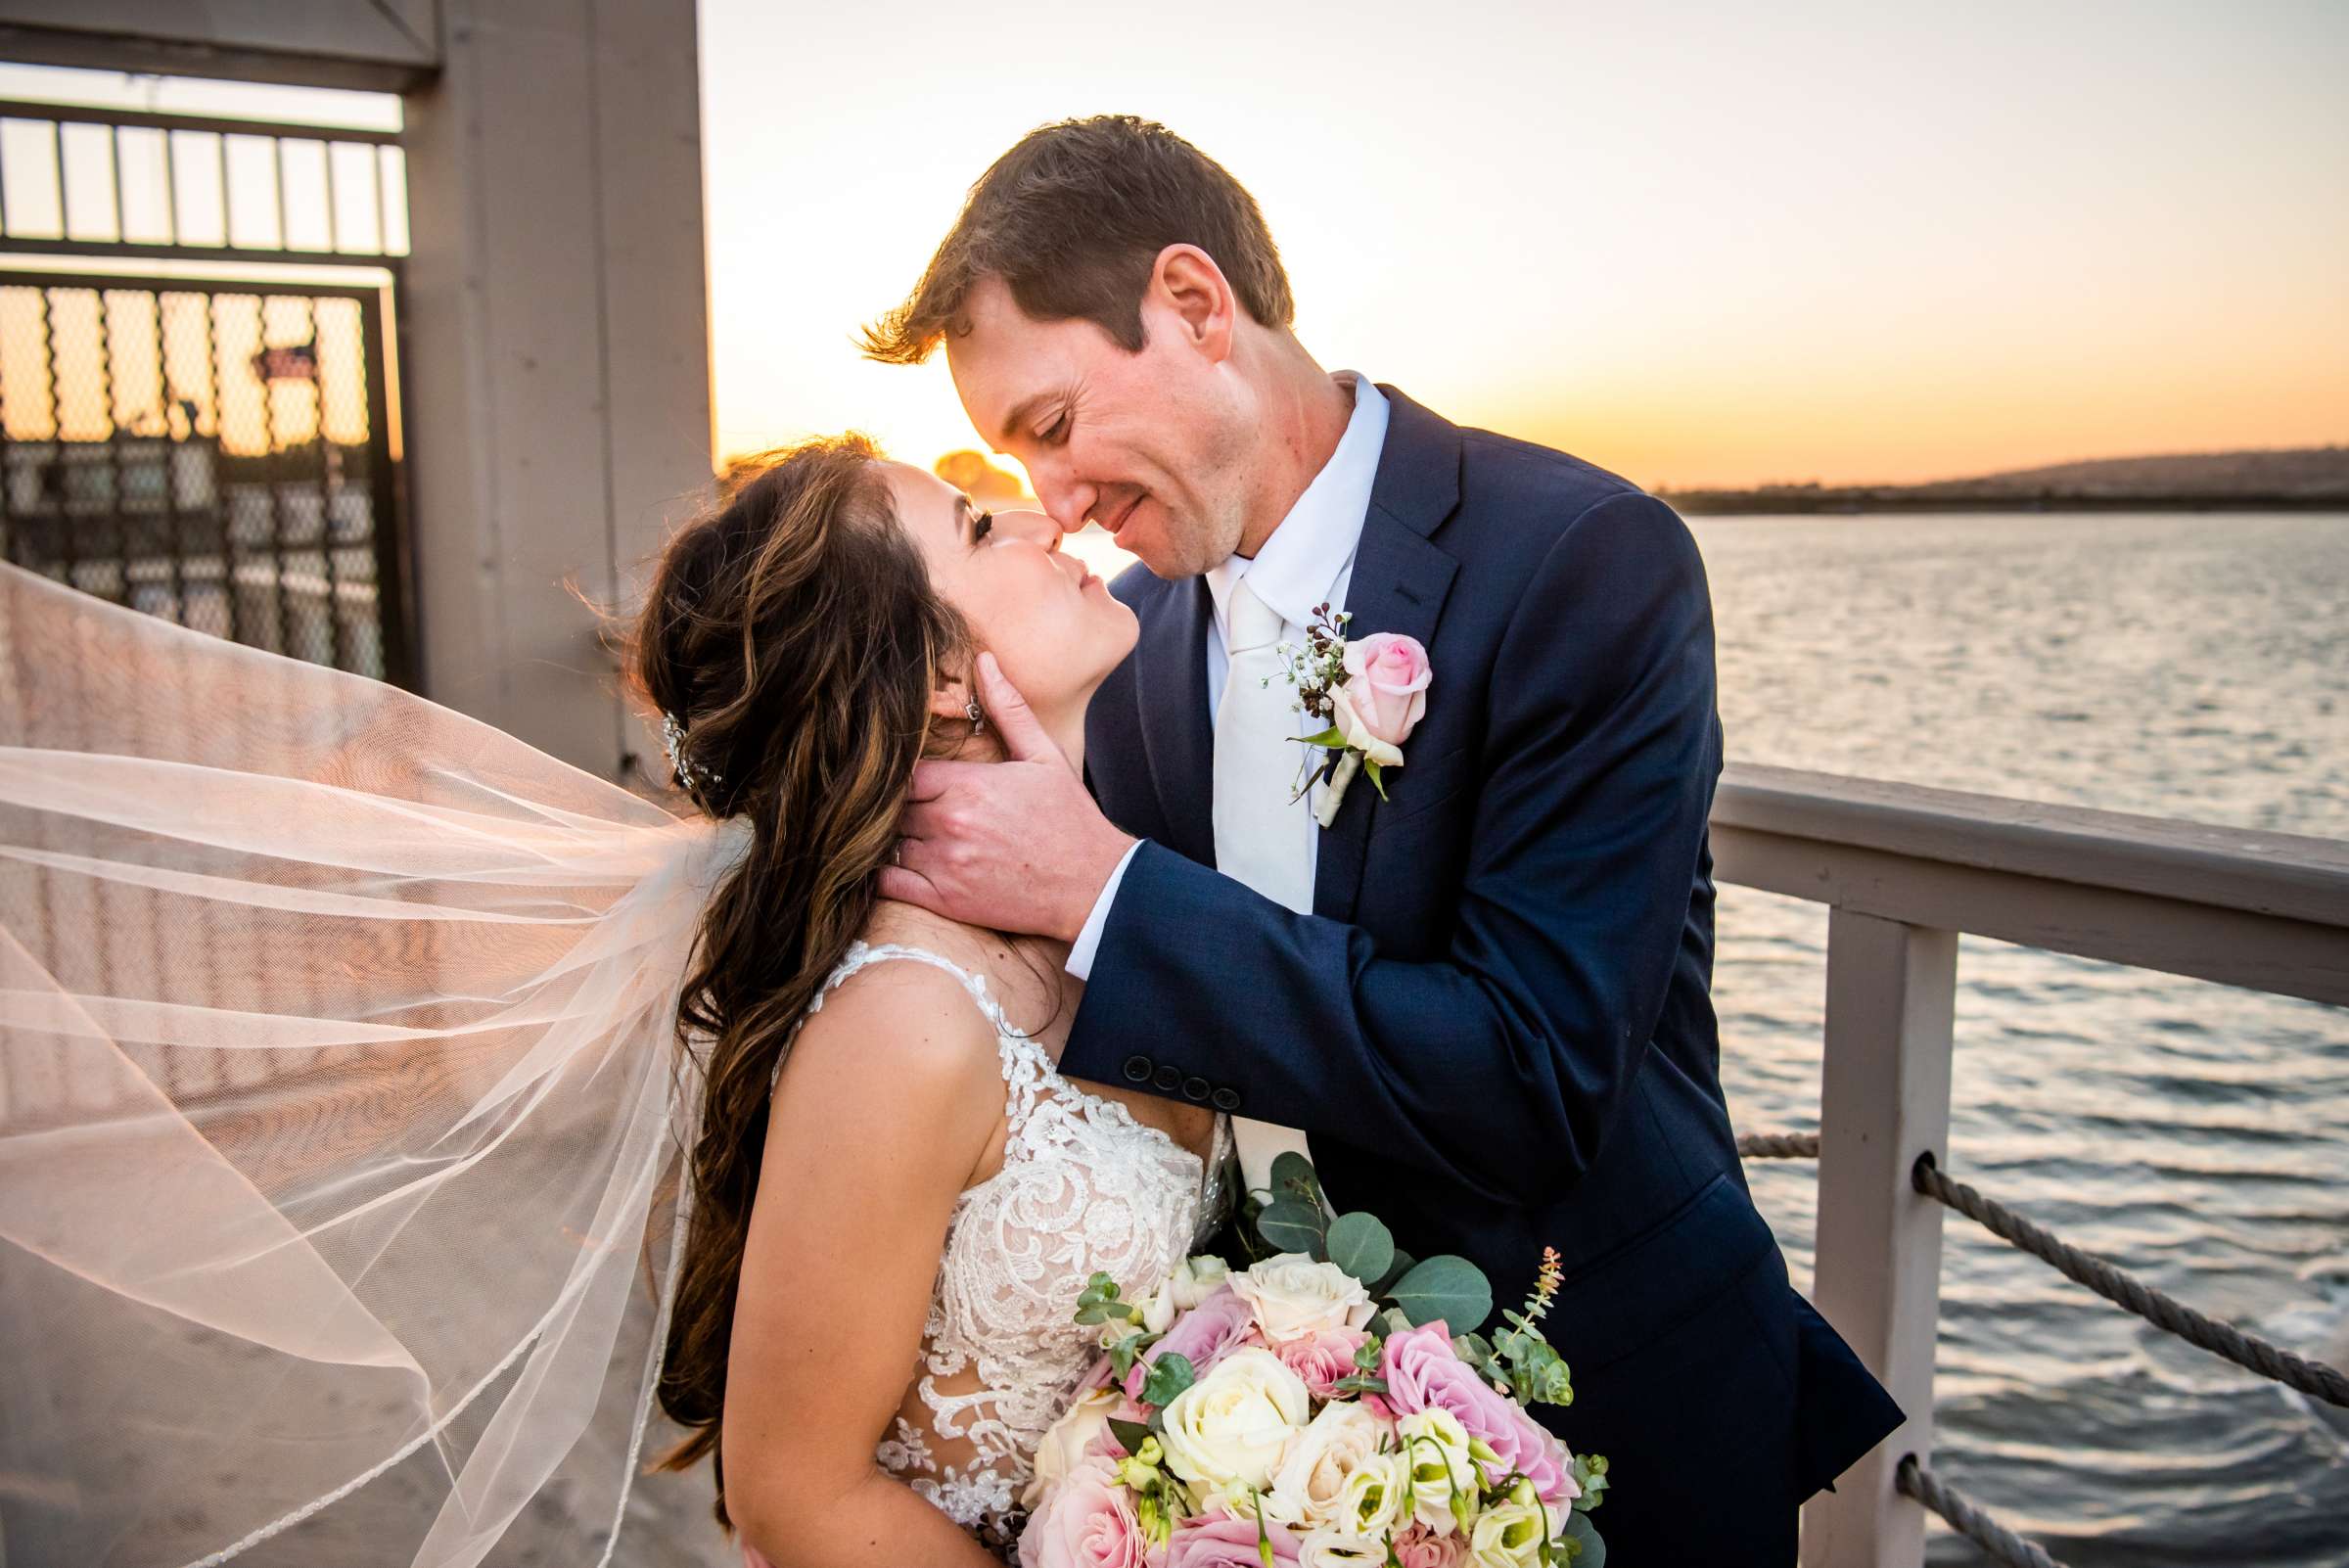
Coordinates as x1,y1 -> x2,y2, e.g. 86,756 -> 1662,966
0,568 -> 742,1568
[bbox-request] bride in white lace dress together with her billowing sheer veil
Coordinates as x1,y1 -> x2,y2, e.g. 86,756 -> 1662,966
0,437 -> 1228,1568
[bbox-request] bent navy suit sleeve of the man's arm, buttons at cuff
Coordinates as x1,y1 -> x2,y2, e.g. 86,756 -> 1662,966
1062,493 -> 1720,1202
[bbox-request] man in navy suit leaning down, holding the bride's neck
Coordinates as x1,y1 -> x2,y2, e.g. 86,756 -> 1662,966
867,117 -> 1901,1568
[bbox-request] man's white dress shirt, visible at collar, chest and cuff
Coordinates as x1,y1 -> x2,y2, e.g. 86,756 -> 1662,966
1067,371 -> 1388,979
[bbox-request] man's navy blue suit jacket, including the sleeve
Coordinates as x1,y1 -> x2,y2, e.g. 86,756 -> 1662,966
1062,388 -> 1898,1563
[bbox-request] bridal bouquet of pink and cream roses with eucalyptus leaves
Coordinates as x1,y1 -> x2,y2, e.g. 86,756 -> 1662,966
1020,1155 -> 1607,1568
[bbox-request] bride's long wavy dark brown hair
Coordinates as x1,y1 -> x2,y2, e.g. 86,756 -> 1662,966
629,437 -> 970,1523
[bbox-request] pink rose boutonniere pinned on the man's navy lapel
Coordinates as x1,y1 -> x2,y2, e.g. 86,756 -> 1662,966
1278,603 -> 1428,826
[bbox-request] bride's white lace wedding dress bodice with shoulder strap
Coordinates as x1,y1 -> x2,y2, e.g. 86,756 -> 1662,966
775,942 -> 1233,1551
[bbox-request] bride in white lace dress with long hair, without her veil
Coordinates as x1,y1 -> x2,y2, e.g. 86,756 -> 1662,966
636,441 -> 1223,1568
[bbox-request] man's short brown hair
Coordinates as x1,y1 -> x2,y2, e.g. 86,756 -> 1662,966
864,115 -> 1297,364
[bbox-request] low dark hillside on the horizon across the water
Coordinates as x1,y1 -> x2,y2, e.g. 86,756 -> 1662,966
1658,446 -> 2349,512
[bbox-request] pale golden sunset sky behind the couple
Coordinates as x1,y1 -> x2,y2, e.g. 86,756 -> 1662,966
0,0 -> 2349,485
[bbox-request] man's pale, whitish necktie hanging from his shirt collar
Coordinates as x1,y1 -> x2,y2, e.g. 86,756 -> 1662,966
1215,577 -> 1313,1187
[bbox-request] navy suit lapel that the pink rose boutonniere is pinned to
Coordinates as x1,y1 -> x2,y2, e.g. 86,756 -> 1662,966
1313,385 -> 1461,925
